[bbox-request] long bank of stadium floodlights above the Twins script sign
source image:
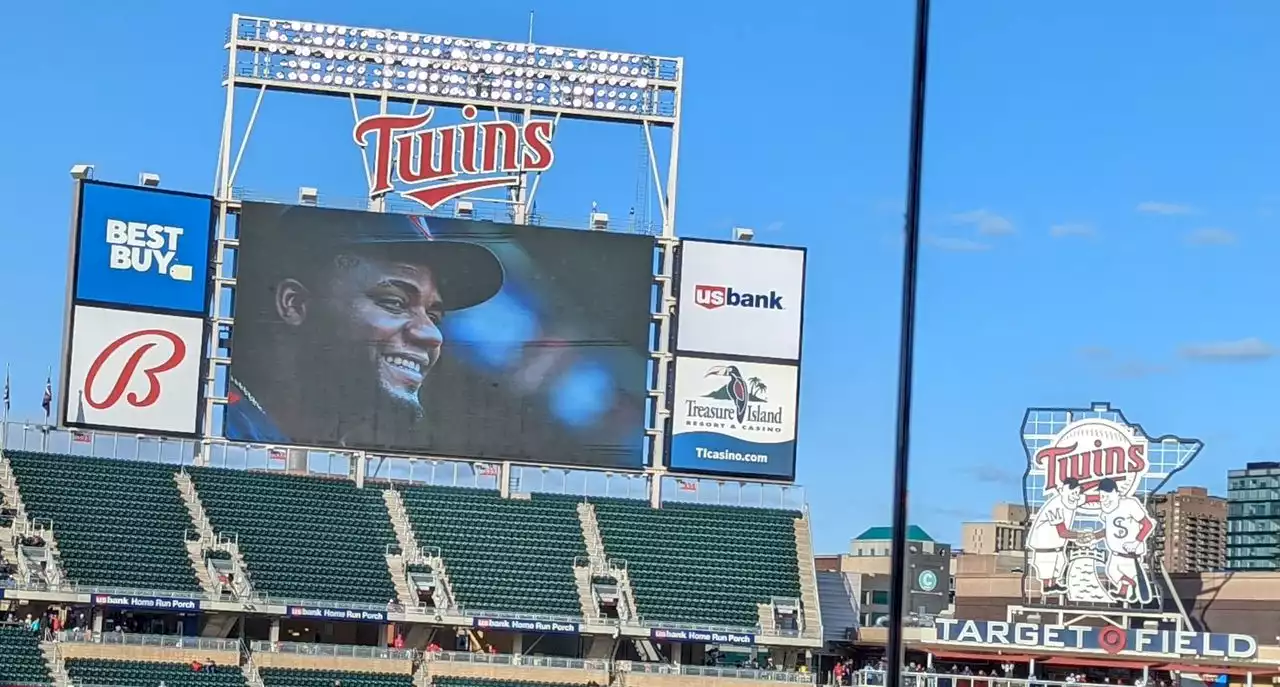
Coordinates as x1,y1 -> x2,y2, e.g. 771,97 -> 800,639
230,17 -> 682,125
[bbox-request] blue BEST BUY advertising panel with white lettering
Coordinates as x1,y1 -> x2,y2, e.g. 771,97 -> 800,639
72,182 -> 214,315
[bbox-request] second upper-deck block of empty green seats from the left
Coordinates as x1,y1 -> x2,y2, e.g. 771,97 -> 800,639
189,468 -> 396,604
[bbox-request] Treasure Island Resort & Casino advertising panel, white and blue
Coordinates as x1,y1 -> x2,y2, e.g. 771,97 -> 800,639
668,356 -> 799,480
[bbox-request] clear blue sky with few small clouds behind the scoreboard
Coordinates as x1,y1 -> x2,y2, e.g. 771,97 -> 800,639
0,0 -> 1280,551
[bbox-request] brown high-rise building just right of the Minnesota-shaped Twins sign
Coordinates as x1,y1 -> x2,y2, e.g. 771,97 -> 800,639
1147,486 -> 1226,573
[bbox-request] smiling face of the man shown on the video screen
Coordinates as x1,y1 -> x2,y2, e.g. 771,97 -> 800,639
307,250 -> 444,416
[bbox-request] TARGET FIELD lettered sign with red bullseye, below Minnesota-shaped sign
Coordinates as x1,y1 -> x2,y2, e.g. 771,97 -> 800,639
934,618 -> 1258,660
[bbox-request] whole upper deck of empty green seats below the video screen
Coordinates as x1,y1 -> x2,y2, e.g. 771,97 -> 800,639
0,417 -> 822,658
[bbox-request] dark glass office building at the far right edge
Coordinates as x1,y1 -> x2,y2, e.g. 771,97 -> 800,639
1226,462 -> 1280,571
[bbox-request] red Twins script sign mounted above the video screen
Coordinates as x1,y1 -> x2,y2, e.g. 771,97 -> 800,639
352,105 -> 556,210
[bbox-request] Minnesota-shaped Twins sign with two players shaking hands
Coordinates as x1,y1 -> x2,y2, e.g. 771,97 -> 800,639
1024,404 -> 1201,606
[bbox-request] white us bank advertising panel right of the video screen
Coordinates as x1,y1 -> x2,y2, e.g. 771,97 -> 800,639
676,239 -> 805,361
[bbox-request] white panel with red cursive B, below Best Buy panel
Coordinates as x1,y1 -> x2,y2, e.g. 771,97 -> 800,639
61,306 -> 205,434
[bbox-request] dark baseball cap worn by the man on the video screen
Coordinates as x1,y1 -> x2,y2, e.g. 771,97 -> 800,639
250,203 -> 503,310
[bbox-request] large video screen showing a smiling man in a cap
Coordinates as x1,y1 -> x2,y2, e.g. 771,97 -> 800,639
224,202 -> 654,470
